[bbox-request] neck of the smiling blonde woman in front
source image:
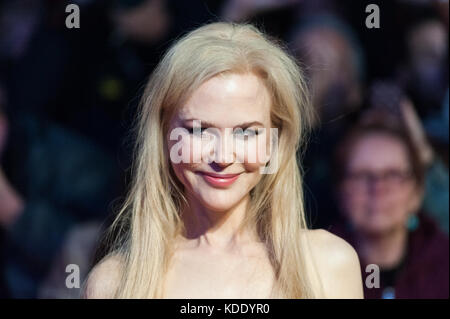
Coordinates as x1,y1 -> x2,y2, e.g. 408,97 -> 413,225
178,196 -> 258,250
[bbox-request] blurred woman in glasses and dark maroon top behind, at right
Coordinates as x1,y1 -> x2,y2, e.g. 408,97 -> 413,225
331,106 -> 449,299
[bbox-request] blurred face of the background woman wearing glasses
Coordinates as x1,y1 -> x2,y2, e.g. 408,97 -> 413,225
340,133 -> 420,234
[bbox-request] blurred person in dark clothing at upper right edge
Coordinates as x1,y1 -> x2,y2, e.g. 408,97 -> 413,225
399,17 -> 449,226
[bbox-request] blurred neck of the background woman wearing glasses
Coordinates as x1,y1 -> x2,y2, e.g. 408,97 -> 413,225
357,227 -> 408,269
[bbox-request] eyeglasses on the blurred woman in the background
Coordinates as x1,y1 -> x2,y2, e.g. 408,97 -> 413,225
344,169 -> 413,187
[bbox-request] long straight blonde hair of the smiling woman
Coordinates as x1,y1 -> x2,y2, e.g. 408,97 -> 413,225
103,22 -> 314,298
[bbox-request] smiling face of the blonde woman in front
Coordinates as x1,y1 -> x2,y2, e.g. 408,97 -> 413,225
167,73 -> 271,212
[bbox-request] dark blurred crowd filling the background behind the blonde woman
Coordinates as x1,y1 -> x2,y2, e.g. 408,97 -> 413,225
0,0 -> 449,298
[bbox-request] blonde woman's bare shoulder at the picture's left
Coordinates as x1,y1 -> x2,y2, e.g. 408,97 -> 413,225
83,255 -> 122,299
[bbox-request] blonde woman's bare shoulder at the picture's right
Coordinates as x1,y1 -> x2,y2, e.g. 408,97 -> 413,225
304,229 -> 363,298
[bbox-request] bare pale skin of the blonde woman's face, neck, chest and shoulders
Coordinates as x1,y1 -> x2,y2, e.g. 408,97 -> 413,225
86,73 -> 363,299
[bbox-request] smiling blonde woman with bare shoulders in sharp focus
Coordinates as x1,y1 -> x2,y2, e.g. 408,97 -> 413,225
84,23 -> 362,298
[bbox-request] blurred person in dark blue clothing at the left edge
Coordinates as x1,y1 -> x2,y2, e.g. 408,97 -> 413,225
0,79 -> 119,298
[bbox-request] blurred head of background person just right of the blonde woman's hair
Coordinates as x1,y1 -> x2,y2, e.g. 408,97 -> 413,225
290,14 -> 364,129
